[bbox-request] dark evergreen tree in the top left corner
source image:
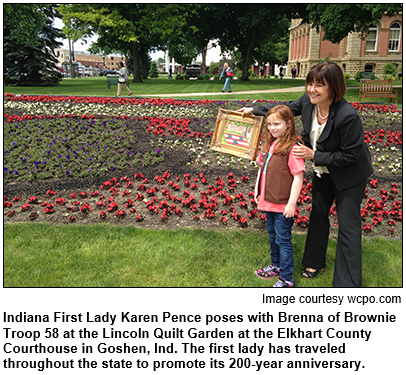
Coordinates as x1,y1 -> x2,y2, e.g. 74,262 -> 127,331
3,4 -> 63,86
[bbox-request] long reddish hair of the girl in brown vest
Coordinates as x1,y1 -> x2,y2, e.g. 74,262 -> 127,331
263,104 -> 301,155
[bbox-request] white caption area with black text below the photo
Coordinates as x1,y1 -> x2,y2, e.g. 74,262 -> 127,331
0,288 -> 406,374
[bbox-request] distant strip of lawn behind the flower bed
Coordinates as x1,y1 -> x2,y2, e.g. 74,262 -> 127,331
3,76 -> 403,108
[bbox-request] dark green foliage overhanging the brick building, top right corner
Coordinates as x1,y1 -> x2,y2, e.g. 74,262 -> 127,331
307,3 -> 402,43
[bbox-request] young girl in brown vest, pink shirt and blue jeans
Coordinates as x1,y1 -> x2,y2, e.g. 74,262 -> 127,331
255,105 -> 305,288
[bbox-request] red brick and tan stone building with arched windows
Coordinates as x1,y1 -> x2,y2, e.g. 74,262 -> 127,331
288,14 -> 403,78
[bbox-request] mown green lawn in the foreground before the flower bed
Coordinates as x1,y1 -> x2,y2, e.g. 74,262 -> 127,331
4,223 -> 402,287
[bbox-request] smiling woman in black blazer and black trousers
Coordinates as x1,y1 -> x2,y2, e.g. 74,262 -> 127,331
240,62 -> 373,287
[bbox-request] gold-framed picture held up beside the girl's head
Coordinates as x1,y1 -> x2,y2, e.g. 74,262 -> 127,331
210,109 -> 265,160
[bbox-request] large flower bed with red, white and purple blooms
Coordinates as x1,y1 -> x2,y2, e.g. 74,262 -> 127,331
3,94 -> 403,238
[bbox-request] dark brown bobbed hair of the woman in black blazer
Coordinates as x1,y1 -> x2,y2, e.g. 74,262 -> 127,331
306,62 -> 347,102
